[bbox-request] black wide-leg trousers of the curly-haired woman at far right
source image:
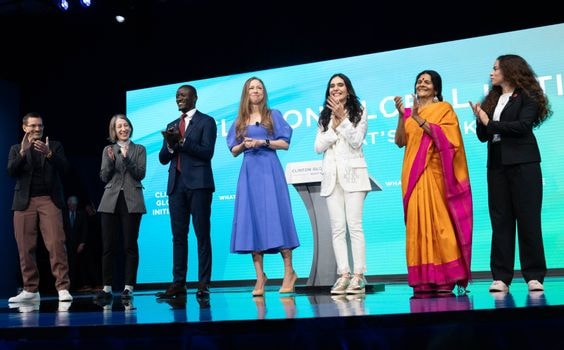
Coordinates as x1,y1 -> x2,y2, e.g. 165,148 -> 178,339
488,144 -> 546,285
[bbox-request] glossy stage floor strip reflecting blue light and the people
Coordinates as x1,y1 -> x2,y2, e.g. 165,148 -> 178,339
0,277 -> 564,329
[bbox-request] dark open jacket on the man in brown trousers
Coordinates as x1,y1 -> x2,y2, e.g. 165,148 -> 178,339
8,141 -> 69,210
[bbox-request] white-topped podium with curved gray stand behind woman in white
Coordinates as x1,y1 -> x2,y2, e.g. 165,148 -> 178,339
286,160 -> 382,287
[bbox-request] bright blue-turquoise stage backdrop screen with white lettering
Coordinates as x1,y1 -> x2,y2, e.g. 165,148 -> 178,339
127,24 -> 564,283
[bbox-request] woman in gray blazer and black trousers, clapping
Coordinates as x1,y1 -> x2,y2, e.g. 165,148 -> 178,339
96,114 -> 147,303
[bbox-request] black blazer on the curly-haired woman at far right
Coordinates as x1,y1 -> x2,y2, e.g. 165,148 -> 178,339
476,89 -> 541,167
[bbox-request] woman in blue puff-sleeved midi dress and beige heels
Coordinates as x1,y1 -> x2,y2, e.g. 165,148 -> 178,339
227,77 -> 300,296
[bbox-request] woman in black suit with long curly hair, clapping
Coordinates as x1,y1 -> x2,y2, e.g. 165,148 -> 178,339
470,55 -> 552,292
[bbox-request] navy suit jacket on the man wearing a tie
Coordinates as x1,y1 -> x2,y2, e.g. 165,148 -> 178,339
159,111 -> 217,195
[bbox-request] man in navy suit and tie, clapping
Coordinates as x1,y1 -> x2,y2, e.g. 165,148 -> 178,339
157,85 -> 217,298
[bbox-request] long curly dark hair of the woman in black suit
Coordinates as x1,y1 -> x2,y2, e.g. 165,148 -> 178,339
482,54 -> 553,128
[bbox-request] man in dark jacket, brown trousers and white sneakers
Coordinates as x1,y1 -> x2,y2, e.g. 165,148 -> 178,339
8,112 -> 73,303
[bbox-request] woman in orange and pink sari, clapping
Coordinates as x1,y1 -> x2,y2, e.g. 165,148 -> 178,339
394,70 -> 473,296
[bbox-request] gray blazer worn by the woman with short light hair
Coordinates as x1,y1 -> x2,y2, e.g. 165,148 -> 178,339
98,142 -> 147,214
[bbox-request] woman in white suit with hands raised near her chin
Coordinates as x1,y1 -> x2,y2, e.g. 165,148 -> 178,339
315,73 -> 371,294
